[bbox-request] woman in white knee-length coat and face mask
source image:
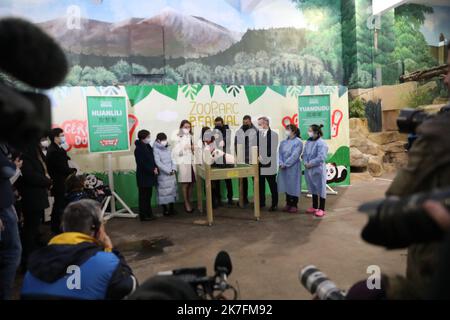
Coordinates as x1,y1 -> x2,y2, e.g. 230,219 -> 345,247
172,120 -> 195,213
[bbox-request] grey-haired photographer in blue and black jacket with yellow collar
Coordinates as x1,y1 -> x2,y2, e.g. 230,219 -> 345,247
21,200 -> 137,300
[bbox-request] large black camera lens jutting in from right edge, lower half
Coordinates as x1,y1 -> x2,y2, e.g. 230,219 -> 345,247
359,189 -> 450,249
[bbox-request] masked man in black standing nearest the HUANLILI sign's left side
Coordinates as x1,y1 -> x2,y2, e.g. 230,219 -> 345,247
47,128 -> 77,234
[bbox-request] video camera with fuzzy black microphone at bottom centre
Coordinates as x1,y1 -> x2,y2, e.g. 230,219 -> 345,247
157,251 -> 238,300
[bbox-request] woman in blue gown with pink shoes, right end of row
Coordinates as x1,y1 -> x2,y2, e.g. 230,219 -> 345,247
303,124 -> 328,217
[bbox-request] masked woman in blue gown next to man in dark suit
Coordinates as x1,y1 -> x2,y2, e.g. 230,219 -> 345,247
278,124 -> 303,213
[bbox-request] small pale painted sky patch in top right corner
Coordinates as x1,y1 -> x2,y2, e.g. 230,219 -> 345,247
421,6 -> 450,46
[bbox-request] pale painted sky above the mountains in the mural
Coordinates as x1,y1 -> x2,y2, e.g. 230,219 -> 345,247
0,0 -> 306,31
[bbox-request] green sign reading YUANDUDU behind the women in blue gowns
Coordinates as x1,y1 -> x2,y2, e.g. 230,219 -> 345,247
298,95 -> 331,140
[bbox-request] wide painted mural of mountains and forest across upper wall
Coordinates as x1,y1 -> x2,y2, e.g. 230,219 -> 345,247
0,0 -> 450,88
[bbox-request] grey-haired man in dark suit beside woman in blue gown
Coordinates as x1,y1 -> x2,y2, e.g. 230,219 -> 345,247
258,116 -> 278,211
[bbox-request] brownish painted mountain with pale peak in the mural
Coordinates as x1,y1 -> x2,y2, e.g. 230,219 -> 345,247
38,9 -> 242,58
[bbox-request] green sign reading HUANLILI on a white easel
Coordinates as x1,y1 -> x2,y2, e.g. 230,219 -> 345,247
87,96 -> 130,153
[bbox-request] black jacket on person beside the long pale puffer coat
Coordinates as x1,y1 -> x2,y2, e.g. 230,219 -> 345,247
134,140 -> 157,188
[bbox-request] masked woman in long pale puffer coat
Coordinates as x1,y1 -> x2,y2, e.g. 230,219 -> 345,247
153,132 -> 177,216
